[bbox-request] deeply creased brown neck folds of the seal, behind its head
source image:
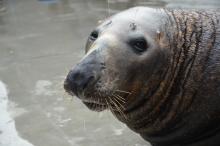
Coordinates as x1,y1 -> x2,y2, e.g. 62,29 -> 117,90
115,10 -> 217,139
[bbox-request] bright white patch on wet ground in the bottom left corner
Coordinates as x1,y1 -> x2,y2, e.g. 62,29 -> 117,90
0,81 -> 33,146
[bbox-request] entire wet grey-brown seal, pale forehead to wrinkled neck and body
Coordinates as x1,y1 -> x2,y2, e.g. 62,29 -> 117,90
64,7 -> 220,146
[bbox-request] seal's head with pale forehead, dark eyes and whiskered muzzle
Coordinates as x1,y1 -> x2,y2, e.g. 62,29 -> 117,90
64,7 -> 167,114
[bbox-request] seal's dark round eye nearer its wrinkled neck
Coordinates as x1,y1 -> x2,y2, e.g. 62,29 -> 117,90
129,37 -> 148,54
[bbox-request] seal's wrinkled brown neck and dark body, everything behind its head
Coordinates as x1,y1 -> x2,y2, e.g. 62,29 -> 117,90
123,10 -> 220,146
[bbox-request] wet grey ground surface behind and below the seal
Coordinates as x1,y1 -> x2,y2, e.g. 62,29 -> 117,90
0,0 -> 220,146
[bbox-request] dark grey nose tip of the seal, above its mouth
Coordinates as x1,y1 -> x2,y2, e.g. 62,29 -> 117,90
64,69 -> 95,96
